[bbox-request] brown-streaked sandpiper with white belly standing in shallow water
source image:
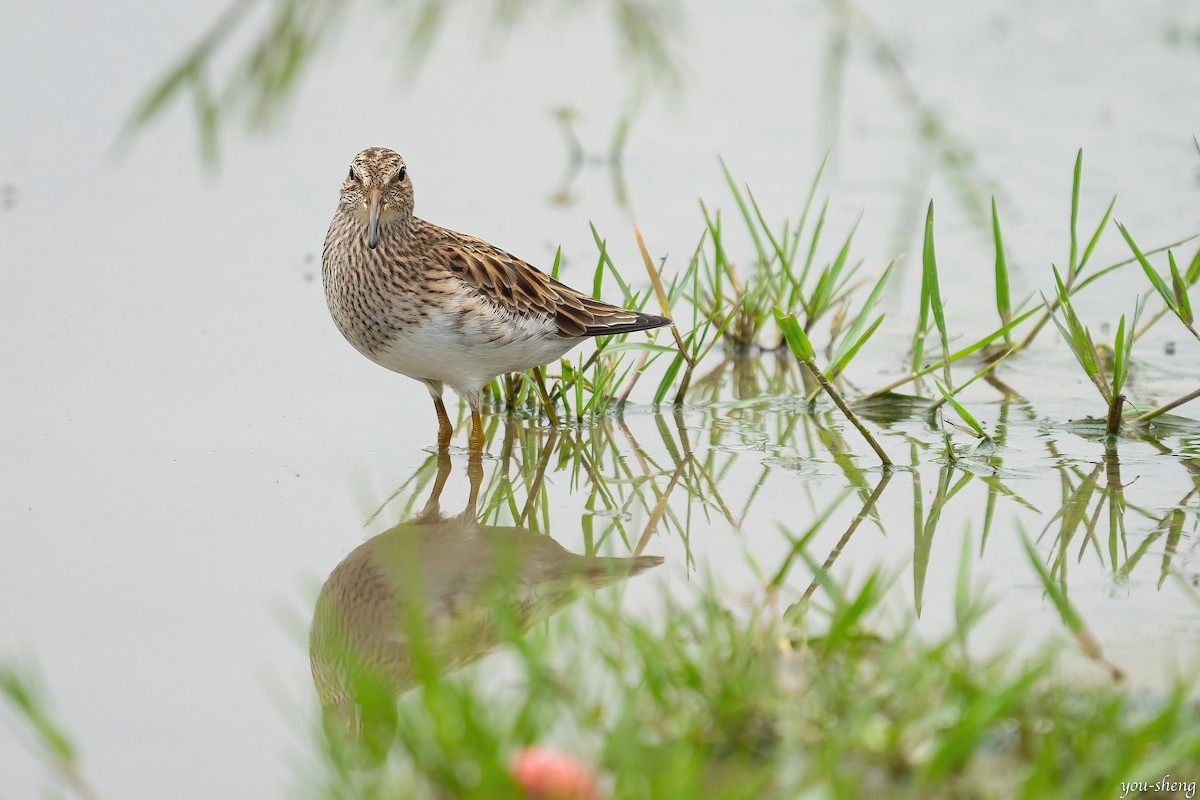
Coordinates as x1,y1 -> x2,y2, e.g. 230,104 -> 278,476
322,148 -> 671,452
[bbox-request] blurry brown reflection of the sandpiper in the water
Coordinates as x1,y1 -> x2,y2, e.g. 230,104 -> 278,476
310,453 -> 662,759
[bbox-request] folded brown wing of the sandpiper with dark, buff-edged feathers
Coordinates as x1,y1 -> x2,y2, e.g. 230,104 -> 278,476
433,229 -> 671,338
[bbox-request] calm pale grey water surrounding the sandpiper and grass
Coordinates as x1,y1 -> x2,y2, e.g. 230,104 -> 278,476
0,0 -> 1200,798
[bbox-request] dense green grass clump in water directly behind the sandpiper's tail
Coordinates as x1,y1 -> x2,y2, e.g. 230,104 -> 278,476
485,162 -> 892,422
